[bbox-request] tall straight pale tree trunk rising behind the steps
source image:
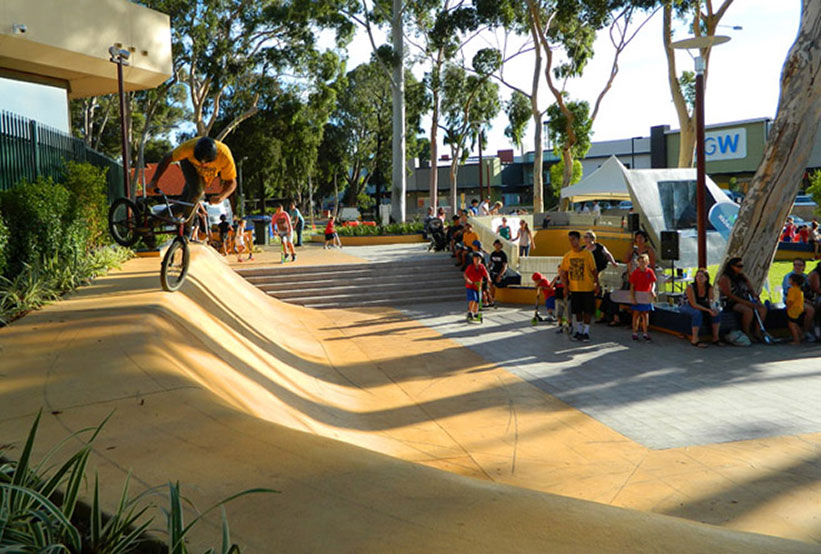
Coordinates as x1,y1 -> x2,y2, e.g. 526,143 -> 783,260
391,0 -> 406,223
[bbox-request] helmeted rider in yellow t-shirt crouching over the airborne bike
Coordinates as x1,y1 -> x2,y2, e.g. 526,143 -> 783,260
148,137 -> 237,218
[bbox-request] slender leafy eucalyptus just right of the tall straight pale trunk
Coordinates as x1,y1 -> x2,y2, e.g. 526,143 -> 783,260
442,54 -> 501,210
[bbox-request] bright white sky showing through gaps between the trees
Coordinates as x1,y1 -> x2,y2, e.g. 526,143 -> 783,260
340,0 -> 801,152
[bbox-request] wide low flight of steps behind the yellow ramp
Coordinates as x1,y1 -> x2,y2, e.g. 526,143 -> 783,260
237,253 -> 465,308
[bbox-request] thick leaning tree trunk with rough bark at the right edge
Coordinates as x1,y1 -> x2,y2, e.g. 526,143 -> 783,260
727,0 -> 821,290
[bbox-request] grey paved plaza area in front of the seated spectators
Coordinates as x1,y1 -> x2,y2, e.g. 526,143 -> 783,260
404,303 -> 821,449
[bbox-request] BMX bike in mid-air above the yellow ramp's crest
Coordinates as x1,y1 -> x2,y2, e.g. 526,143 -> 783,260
108,192 -> 202,292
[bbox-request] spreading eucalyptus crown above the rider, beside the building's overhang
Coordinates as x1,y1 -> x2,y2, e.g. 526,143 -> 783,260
140,0 -> 353,139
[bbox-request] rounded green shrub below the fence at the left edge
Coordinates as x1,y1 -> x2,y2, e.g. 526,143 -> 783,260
0,179 -> 71,275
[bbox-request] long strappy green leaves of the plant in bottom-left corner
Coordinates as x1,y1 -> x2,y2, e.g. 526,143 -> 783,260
0,412 -> 277,554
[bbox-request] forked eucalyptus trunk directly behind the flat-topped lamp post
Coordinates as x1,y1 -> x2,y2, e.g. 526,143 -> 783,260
660,0 -> 733,167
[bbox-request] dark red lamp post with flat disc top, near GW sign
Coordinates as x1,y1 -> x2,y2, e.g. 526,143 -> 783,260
673,35 -> 730,267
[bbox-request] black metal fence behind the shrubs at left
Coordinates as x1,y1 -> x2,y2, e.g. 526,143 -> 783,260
0,111 -> 123,203
